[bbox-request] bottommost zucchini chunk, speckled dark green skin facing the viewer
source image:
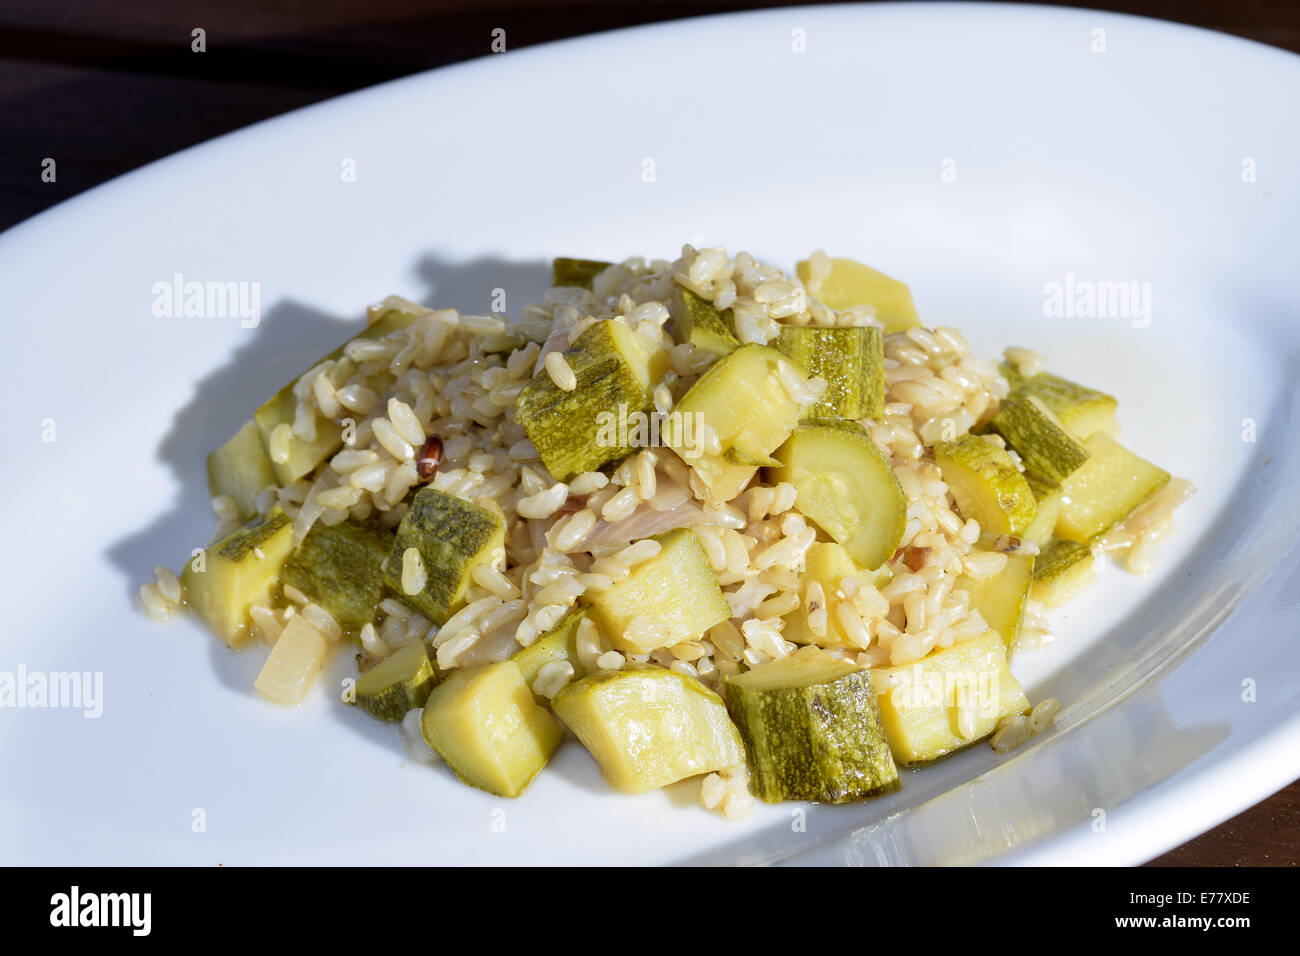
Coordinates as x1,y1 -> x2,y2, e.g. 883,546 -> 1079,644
725,648 -> 898,804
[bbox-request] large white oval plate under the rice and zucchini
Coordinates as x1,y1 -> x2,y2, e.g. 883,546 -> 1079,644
0,4 -> 1300,864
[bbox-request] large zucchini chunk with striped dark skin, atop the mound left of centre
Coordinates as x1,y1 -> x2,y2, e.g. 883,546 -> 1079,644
515,320 -> 668,481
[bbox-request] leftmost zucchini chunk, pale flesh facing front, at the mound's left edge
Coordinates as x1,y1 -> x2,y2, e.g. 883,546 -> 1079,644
181,505 -> 294,649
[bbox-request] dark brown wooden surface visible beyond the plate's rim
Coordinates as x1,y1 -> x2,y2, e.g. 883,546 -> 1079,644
0,0 -> 1300,866
